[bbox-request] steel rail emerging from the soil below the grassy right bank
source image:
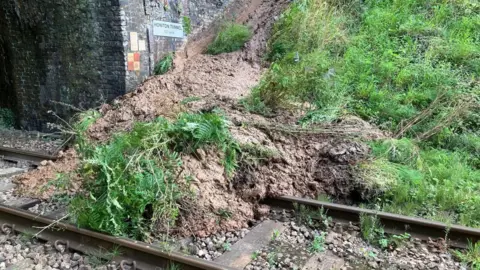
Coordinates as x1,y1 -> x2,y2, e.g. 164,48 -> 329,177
264,196 -> 480,248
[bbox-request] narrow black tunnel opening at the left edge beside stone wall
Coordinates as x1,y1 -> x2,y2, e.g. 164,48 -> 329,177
0,35 -> 18,127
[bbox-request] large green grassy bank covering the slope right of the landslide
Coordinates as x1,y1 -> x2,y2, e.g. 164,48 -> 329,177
246,0 -> 480,227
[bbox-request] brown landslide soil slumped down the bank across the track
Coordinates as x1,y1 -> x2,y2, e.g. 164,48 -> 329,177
17,0 -> 383,236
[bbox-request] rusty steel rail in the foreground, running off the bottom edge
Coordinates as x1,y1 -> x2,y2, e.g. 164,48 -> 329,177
0,205 -> 233,270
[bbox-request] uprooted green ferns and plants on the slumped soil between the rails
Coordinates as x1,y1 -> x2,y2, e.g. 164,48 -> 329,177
69,111 -> 239,239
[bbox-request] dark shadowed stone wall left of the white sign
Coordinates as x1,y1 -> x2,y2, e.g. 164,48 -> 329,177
0,0 -> 125,130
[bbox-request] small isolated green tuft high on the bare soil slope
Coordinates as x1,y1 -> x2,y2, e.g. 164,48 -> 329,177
207,22 -> 252,55
